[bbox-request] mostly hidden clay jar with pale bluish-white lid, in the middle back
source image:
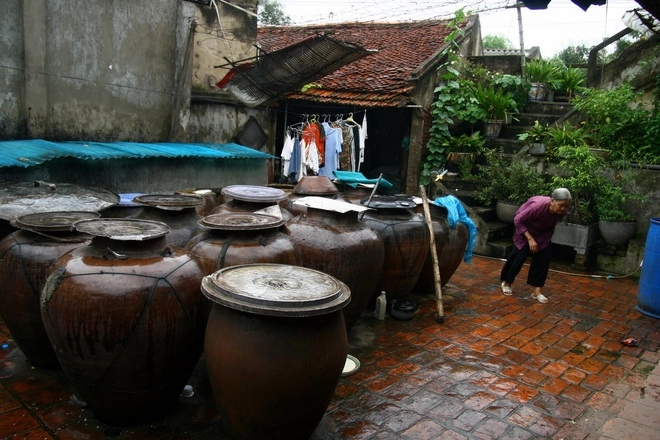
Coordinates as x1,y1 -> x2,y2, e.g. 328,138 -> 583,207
211,185 -> 293,221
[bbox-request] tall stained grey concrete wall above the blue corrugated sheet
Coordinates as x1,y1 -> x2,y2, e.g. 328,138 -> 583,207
0,0 -> 273,151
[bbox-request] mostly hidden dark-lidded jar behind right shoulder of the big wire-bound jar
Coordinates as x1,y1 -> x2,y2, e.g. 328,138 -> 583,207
133,194 -> 205,247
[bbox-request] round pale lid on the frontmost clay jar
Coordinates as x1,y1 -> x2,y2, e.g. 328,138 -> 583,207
202,264 -> 351,317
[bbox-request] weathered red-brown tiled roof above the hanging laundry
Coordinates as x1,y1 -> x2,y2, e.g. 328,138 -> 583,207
257,20 -> 458,107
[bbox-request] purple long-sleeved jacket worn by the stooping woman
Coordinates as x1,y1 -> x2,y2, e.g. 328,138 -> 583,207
513,196 -> 563,250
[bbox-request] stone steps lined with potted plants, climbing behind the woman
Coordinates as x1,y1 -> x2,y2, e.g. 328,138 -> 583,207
435,101 -> 573,258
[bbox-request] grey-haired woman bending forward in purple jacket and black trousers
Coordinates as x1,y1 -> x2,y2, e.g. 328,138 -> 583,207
500,188 -> 572,303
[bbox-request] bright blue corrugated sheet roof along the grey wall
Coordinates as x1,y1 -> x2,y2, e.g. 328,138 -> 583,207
0,139 -> 275,167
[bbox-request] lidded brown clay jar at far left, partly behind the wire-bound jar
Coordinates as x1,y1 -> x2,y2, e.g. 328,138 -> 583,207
0,211 -> 99,368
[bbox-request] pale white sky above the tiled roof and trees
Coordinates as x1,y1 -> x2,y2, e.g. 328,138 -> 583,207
279,0 -> 640,58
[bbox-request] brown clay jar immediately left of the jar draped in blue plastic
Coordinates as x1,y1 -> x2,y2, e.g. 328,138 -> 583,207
362,195 -> 431,300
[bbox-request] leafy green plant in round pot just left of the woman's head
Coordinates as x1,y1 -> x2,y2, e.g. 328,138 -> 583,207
474,150 -> 550,223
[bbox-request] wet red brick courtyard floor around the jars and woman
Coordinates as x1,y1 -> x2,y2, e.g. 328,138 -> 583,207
0,256 -> 660,440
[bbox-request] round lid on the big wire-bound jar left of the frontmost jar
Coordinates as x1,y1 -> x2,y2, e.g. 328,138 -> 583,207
73,218 -> 170,241
